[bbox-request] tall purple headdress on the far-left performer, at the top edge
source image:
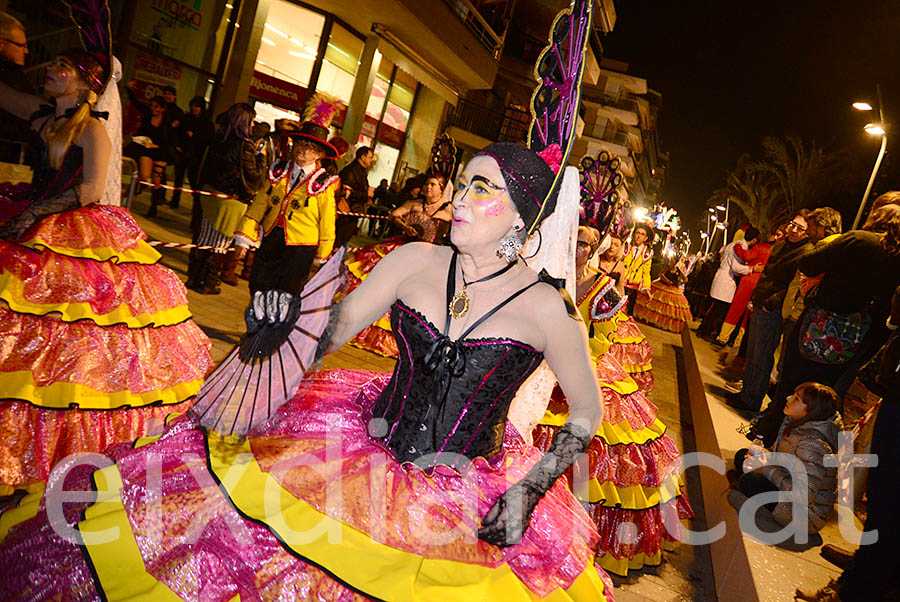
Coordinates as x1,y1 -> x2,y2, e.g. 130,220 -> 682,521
62,0 -> 112,94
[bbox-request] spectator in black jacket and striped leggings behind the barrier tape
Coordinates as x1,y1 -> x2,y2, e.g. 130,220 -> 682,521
187,102 -> 268,295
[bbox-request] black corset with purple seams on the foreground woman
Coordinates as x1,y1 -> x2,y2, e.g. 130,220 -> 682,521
369,301 -> 543,467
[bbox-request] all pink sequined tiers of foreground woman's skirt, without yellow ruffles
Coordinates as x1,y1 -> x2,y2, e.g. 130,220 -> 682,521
0,370 -> 613,602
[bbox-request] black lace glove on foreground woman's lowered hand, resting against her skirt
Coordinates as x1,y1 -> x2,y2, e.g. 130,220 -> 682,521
478,422 -> 592,548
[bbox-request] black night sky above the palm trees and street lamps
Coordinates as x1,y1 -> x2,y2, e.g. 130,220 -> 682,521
603,0 -> 900,238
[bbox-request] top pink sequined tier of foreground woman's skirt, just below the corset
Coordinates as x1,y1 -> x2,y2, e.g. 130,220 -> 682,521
252,370 -> 596,596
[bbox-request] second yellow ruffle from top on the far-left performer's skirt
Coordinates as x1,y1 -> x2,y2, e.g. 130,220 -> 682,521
0,271 -> 191,328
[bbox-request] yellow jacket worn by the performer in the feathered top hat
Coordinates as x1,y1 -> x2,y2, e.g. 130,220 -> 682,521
234,162 -> 341,259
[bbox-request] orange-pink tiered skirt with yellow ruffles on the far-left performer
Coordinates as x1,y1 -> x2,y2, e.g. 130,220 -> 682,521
0,198 -> 211,495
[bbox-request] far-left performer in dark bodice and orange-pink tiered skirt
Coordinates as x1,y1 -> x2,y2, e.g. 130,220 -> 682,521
0,3 -> 211,494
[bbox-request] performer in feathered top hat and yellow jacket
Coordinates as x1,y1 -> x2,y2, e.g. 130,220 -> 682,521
234,94 -> 340,295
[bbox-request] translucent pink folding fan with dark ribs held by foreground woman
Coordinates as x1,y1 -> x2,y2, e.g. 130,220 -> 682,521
191,248 -> 344,437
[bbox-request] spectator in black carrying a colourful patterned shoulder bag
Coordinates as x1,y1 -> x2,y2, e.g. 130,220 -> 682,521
754,205 -> 900,442
